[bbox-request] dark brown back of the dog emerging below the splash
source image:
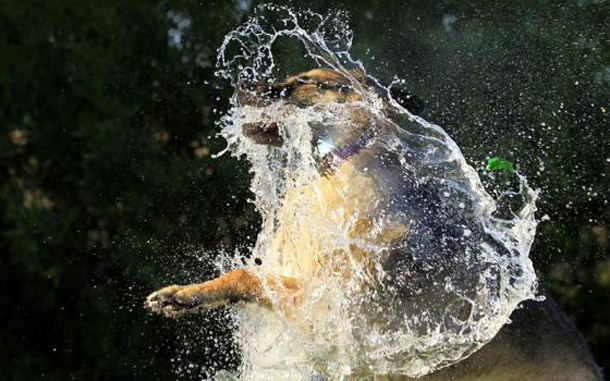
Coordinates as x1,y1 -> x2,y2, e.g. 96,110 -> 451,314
410,296 -> 603,381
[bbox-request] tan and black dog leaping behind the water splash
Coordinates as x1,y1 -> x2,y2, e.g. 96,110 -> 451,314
145,68 -> 602,381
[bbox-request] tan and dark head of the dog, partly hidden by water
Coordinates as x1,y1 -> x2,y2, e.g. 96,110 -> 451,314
237,68 -> 423,146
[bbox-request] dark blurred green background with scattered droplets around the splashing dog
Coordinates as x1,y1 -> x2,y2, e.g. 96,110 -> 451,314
0,0 -> 610,380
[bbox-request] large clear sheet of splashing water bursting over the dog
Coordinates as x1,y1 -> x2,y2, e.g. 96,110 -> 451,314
211,6 -> 537,380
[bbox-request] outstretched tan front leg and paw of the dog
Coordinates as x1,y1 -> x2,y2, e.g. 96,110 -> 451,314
145,269 -> 298,317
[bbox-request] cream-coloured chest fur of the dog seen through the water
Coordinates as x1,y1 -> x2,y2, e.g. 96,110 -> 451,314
267,153 -> 381,278
